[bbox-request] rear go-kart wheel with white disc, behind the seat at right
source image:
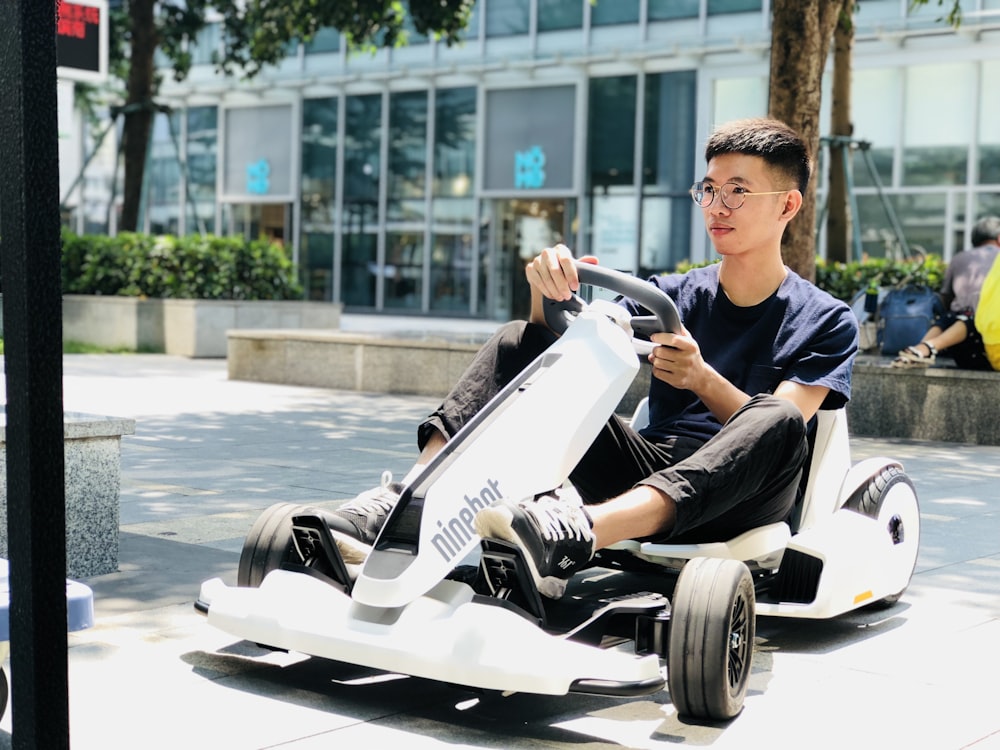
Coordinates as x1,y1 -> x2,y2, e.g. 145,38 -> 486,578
844,466 -> 920,607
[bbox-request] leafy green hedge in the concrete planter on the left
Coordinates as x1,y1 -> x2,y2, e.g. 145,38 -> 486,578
62,230 -> 302,300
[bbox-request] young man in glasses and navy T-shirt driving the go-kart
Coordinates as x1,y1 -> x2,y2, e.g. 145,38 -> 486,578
332,119 -> 858,597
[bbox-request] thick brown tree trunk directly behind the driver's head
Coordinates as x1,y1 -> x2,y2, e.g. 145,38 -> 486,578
768,0 -> 843,281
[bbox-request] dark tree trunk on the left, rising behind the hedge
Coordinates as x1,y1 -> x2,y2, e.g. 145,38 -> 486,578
118,0 -> 157,232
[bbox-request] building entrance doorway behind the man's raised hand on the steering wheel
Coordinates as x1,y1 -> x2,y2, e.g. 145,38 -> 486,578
490,198 -> 577,320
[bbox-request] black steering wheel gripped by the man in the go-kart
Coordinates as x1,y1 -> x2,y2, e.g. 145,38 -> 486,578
542,260 -> 681,352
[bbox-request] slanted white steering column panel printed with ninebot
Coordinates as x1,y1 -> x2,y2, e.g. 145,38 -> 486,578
353,312 -> 639,607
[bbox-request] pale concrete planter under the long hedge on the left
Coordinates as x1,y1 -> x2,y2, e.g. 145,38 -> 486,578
63,294 -> 341,357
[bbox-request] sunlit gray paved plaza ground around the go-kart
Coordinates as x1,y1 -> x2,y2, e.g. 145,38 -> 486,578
0,355 -> 1000,750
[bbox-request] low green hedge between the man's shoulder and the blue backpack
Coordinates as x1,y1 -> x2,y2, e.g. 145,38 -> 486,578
816,255 -> 947,302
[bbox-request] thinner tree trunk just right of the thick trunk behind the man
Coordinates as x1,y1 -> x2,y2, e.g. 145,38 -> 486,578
826,0 -> 860,263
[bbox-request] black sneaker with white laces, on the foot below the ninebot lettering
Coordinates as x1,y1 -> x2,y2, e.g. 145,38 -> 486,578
475,494 -> 595,599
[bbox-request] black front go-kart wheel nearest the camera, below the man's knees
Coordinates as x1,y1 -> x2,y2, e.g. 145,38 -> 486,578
667,557 -> 756,721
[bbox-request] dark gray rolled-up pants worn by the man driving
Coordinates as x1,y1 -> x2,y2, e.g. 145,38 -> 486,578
418,322 -> 809,542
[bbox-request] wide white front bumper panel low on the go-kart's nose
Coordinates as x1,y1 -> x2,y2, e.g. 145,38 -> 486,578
200,570 -> 662,695
